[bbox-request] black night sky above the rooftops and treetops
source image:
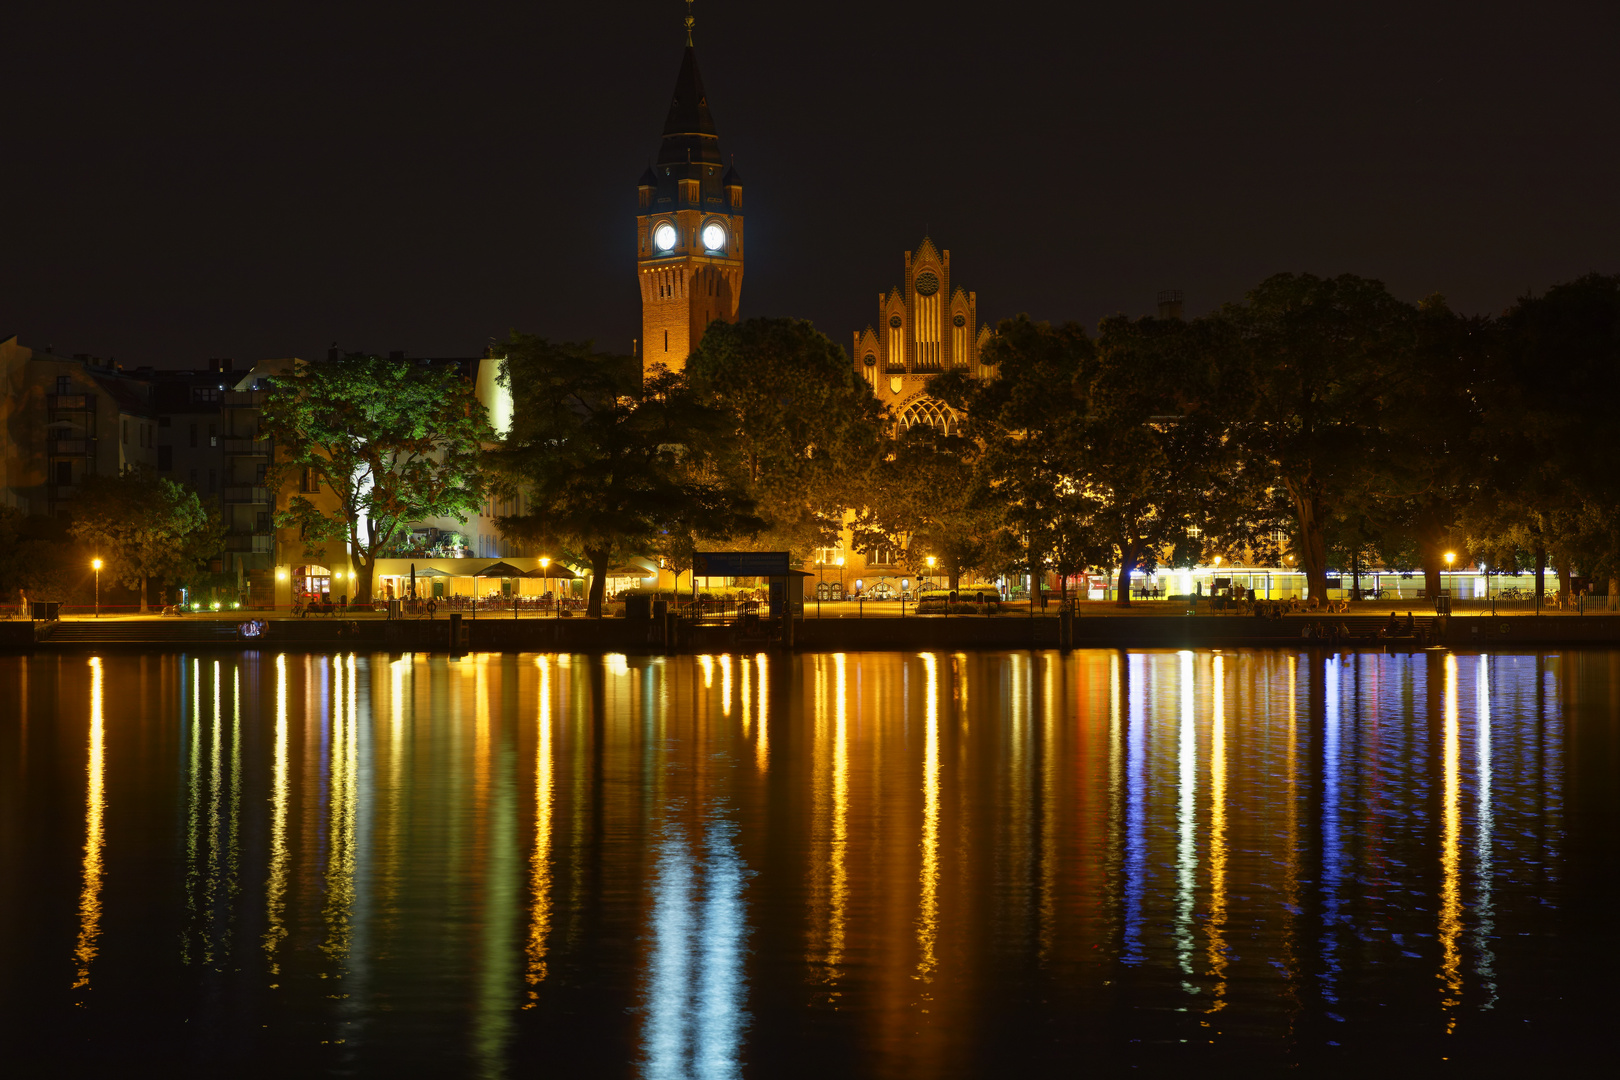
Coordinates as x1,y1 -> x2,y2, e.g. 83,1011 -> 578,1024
0,0 -> 1620,366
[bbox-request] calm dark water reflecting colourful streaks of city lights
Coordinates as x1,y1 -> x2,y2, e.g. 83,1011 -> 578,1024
0,651 -> 1620,1077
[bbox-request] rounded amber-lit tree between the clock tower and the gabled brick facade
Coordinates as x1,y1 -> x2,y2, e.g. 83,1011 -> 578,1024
687,319 -> 885,559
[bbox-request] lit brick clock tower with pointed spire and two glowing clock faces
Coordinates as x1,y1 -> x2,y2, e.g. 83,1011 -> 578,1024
635,8 -> 744,377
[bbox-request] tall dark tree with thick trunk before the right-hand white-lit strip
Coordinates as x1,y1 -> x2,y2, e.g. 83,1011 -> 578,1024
1221,274 -> 1419,596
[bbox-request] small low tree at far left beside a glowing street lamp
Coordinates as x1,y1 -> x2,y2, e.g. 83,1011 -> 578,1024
68,473 -> 224,615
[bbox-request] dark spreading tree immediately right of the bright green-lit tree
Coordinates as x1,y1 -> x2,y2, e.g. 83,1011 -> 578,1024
491,332 -> 763,619
